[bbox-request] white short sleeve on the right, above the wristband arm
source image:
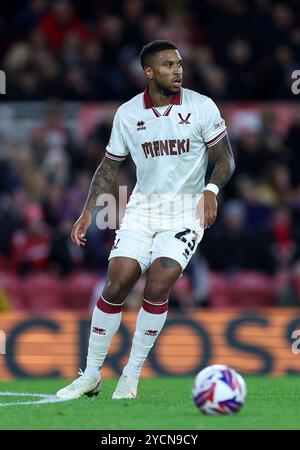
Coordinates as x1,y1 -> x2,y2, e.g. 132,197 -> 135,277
202,98 -> 227,147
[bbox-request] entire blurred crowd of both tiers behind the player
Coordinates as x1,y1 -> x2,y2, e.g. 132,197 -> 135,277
0,0 -> 300,310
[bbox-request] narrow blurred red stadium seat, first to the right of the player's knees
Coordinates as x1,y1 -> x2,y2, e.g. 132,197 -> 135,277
208,272 -> 233,308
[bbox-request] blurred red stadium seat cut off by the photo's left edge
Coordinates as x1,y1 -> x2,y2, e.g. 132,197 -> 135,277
0,270 -> 27,311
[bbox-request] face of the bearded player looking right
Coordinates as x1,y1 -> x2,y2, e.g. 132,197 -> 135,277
146,50 -> 183,96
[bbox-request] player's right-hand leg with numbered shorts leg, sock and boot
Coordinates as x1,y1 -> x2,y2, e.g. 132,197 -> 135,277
113,229 -> 203,399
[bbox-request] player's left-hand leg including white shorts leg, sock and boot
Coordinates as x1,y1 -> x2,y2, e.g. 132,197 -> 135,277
57,221 -> 152,399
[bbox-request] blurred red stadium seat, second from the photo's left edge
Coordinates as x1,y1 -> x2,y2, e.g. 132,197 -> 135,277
22,272 -> 65,312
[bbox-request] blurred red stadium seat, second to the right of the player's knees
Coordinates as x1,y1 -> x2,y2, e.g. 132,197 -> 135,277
230,272 -> 276,308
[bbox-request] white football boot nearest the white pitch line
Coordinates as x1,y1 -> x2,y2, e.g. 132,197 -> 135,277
56,370 -> 101,400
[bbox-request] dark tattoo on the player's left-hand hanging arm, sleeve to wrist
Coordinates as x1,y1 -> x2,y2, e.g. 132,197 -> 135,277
84,156 -> 122,212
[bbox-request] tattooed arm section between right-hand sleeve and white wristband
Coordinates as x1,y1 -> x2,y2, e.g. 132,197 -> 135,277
209,135 -> 235,189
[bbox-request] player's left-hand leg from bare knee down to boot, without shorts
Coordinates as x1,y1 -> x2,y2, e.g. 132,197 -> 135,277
56,257 -> 141,399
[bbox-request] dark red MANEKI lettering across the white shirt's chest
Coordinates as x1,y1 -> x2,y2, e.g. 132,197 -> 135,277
142,139 -> 190,158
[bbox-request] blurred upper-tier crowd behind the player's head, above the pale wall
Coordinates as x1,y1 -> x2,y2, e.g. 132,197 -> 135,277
0,0 -> 300,101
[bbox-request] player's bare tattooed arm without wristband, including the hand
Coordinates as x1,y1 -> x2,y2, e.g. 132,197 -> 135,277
71,156 -> 122,247
